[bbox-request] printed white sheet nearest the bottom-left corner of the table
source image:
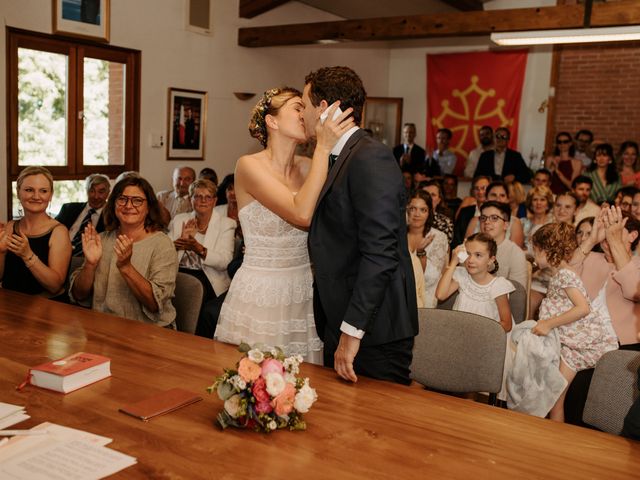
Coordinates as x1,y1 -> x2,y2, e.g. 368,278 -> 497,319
0,435 -> 137,480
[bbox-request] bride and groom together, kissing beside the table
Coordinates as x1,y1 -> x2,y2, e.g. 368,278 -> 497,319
214,67 -> 418,384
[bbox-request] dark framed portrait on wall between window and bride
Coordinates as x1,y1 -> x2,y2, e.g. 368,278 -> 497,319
167,88 -> 207,160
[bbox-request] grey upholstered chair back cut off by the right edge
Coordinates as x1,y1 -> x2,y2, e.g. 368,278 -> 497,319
582,350 -> 640,435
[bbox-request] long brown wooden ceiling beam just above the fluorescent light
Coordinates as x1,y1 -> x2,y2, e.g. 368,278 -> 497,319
238,0 -> 640,47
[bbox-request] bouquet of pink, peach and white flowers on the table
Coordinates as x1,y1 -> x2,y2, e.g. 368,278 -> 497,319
207,343 -> 318,433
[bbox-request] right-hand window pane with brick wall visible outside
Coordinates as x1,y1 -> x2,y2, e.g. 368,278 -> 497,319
83,58 -> 126,165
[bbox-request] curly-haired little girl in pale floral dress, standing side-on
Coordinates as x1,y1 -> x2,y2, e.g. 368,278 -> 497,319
532,223 -> 618,422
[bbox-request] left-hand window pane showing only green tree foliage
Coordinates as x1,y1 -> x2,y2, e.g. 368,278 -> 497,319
18,48 -> 68,166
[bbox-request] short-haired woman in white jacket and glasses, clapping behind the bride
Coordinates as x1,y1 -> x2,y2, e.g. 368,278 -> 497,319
169,180 -> 236,338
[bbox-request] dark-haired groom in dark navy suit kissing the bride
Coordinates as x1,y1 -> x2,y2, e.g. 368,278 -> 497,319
302,67 -> 418,384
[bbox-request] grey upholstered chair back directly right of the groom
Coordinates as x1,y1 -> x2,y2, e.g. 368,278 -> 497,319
411,308 -> 506,405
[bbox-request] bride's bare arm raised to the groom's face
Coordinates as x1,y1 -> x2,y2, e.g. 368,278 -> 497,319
235,104 -> 355,227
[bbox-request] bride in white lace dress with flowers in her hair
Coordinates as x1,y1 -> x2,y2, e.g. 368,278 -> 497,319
214,87 -> 354,364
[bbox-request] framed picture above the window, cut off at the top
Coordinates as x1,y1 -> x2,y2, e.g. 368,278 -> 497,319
52,0 -> 111,42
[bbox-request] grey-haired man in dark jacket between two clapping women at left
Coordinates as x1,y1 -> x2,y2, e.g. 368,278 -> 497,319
56,173 -> 111,257
